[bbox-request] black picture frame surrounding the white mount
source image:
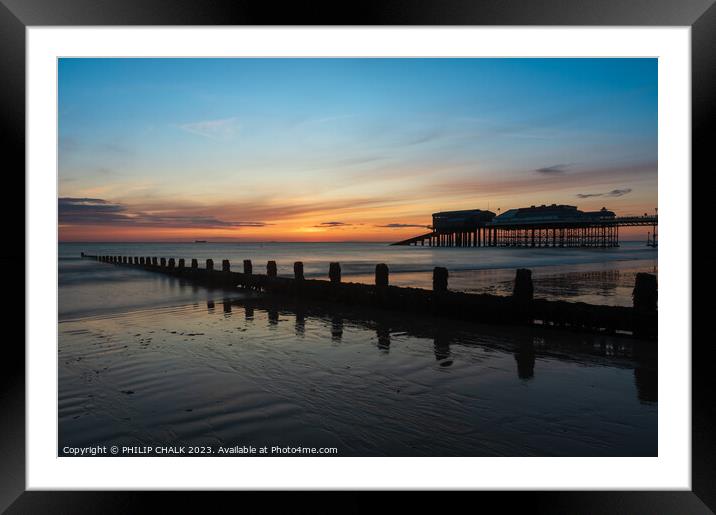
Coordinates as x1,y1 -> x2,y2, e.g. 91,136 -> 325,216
0,0 -> 716,514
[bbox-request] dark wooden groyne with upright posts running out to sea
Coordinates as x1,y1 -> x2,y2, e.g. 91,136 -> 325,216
82,253 -> 658,340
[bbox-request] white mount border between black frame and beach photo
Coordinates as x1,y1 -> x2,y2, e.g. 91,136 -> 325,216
26,27 -> 691,490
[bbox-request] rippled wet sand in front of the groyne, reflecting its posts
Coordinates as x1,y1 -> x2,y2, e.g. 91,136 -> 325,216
59,292 -> 657,456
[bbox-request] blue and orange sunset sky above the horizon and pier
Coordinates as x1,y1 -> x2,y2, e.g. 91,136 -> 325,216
58,59 -> 657,241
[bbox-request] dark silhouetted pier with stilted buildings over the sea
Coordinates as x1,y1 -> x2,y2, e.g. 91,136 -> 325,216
392,204 -> 658,248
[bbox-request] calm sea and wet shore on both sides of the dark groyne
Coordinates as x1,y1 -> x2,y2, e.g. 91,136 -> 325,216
58,244 -> 657,456
